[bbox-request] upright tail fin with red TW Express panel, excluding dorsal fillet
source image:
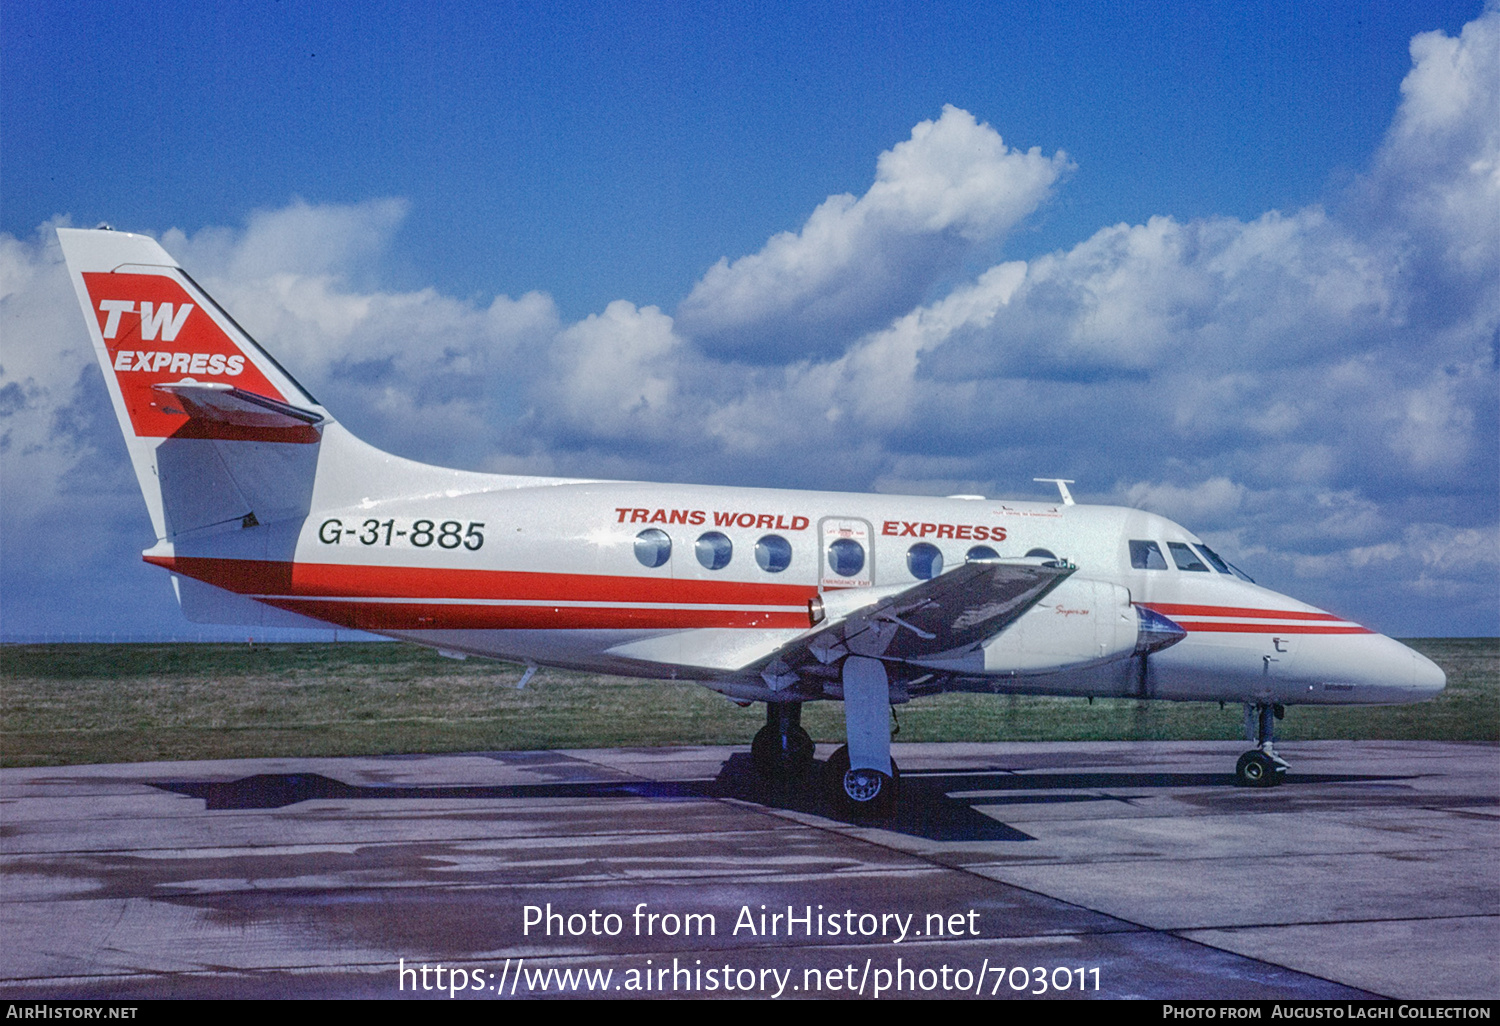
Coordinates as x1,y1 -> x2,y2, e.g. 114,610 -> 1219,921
57,228 -> 329,540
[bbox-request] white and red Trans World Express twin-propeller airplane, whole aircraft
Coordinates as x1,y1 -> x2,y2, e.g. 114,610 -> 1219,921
57,228 -> 1446,818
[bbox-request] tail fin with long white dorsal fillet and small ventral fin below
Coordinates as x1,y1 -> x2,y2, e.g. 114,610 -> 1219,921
57,228 -> 557,626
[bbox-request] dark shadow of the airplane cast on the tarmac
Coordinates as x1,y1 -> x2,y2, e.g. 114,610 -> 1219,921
144,753 -> 1404,842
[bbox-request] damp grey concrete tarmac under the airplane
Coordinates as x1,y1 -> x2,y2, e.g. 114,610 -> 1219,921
0,741 -> 1500,1001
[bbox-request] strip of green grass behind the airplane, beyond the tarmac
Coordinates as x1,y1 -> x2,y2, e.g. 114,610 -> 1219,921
0,638 -> 1500,767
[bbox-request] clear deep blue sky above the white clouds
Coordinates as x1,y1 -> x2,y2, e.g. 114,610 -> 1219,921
0,0 -> 1479,310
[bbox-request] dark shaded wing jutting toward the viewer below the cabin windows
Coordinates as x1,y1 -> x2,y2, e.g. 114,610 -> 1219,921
755,563 -> 1077,690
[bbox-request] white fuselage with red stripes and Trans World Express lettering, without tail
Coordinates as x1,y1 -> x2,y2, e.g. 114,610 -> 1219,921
147,425 -> 1443,704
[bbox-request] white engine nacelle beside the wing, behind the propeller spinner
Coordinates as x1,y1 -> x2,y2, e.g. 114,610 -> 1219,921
984,576 -> 1142,675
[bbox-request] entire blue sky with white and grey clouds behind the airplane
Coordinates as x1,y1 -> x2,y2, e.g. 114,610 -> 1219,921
0,3 -> 1500,635
